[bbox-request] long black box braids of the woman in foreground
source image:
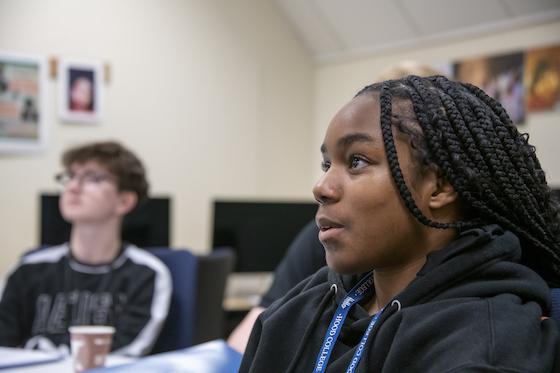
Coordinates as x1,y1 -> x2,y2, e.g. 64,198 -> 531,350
356,75 -> 560,287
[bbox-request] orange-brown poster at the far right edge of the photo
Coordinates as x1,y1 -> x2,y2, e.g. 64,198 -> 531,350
525,45 -> 560,112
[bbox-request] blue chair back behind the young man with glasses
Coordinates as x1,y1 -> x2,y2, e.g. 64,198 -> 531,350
149,248 -> 198,353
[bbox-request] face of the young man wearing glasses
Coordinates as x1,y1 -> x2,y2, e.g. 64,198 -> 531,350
60,161 -> 123,224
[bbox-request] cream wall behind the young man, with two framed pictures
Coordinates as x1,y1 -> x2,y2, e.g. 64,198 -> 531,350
0,0 -> 313,275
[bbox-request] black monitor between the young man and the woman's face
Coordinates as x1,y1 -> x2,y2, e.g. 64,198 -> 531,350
212,201 -> 317,272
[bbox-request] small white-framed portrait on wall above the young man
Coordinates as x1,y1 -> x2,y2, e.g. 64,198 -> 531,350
58,59 -> 103,123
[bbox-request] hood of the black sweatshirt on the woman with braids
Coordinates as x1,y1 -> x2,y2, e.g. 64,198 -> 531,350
327,225 -> 550,316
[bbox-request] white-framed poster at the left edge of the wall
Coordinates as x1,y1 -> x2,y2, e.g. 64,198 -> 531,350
0,52 -> 47,152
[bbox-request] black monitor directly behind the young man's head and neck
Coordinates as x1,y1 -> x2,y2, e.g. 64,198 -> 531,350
39,194 -> 170,247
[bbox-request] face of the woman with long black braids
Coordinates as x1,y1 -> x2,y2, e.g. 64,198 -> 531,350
313,94 -> 431,273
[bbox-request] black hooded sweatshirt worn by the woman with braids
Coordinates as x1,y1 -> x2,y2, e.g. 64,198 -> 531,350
240,225 -> 558,373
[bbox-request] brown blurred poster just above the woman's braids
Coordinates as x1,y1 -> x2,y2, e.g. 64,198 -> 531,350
453,52 -> 525,124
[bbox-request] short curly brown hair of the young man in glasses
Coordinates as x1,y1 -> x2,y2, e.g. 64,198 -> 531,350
62,141 -> 149,204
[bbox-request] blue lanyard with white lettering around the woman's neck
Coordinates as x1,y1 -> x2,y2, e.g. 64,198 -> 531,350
313,273 -> 383,373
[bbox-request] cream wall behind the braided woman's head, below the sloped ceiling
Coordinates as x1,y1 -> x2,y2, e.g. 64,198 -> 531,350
312,22 -> 560,187
